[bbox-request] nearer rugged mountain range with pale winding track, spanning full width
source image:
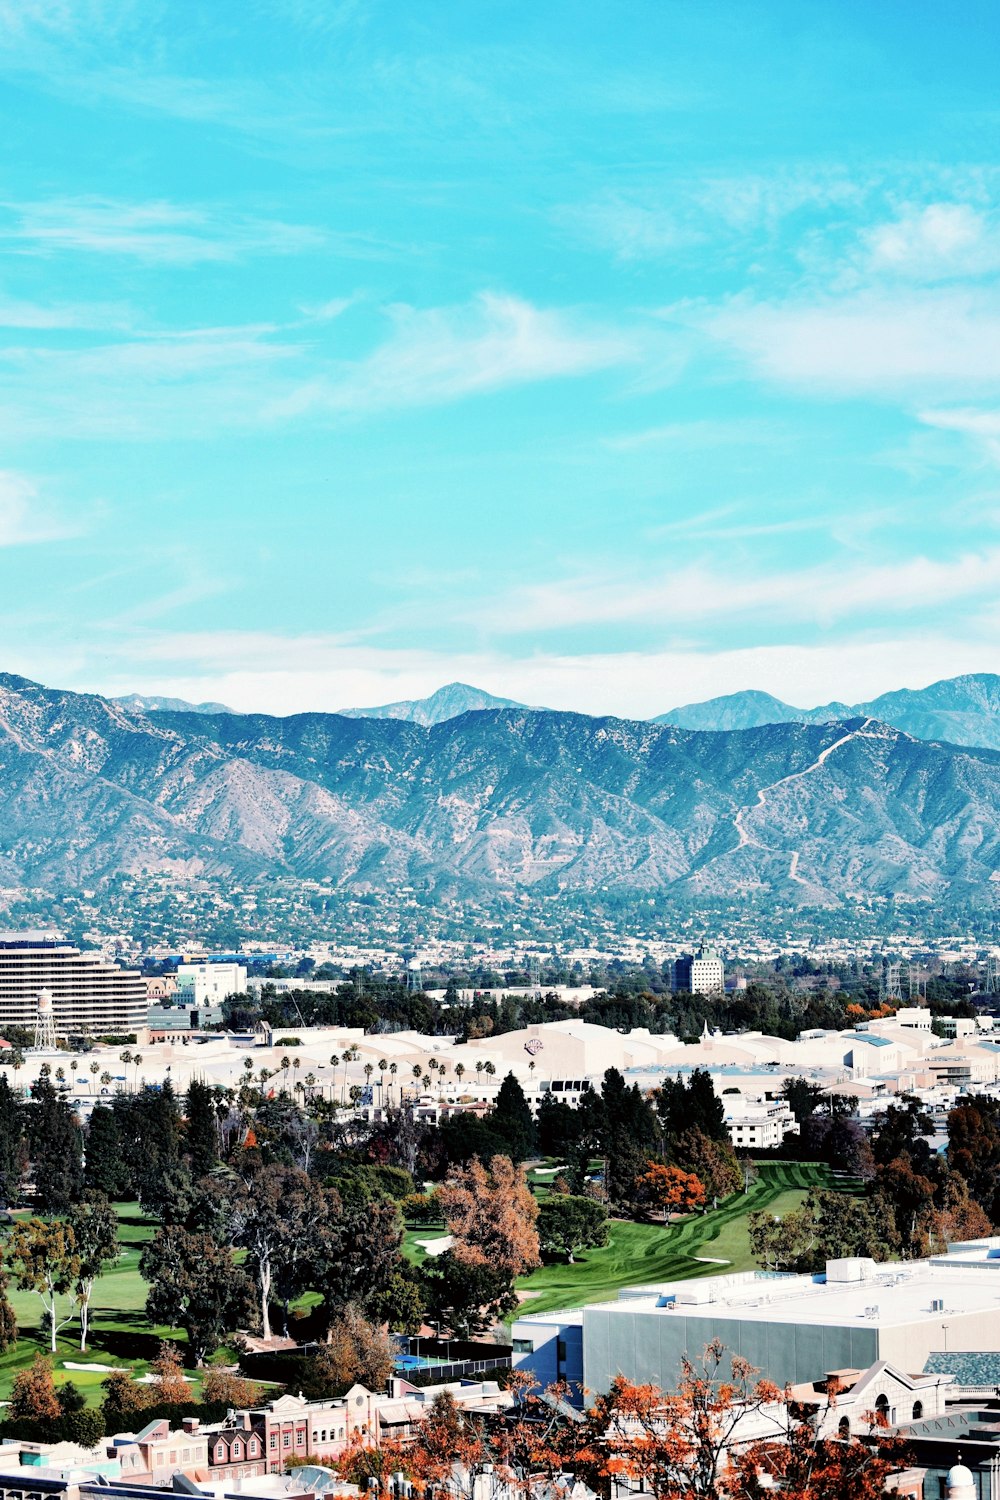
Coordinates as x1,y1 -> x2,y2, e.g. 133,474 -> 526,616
0,675 -> 1000,905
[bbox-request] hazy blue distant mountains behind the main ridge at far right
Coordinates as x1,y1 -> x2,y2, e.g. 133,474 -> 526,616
654,672 -> 1000,750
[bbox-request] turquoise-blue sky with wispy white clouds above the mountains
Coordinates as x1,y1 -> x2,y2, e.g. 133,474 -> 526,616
0,0 -> 1000,716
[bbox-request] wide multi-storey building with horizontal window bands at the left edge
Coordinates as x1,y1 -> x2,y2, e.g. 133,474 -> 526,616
0,932 -> 147,1037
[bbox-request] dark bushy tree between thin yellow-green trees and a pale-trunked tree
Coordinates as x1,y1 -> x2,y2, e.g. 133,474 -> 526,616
139,1224 -> 252,1365
